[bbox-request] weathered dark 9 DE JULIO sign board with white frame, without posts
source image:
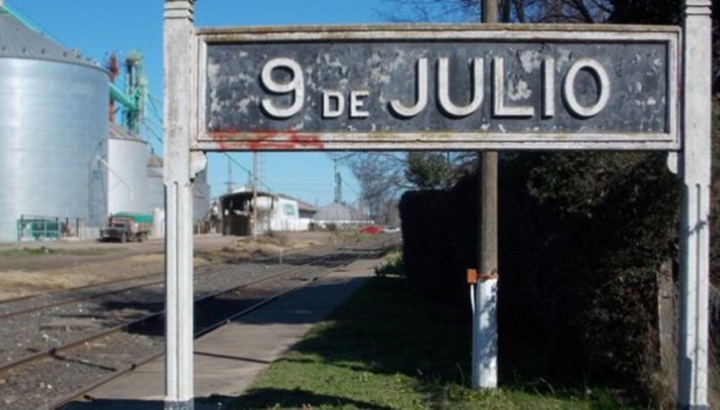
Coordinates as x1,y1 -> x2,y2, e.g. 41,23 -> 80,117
192,25 -> 680,151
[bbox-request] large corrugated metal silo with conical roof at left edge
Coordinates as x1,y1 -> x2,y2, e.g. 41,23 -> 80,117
0,12 -> 108,242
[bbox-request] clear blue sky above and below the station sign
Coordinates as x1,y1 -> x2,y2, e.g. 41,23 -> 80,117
5,0 -> 402,206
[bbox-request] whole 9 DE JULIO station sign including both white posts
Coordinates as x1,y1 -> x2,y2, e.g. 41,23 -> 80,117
163,0 -> 712,410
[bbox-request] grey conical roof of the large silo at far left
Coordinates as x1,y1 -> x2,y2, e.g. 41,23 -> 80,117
0,11 -> 101,69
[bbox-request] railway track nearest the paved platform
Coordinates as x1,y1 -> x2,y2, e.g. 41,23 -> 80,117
0,238 -> 389,410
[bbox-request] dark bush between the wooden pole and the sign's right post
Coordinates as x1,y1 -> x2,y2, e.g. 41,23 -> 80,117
500,153 -> 679,388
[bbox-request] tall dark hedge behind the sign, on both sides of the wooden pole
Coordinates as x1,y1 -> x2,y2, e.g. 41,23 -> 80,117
401,101 -> 720,406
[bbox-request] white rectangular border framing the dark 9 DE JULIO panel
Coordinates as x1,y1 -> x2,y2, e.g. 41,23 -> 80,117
191,24 -> 681,151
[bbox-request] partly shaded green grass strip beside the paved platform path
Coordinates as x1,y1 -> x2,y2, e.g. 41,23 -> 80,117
231,276 -> 640,410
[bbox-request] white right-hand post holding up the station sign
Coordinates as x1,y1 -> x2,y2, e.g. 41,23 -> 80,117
678,0 -> 712,409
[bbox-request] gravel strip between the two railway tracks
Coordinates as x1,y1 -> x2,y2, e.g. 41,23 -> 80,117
0,239 -> 380,371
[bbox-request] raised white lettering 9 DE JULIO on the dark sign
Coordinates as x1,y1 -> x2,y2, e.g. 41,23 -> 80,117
260,56 -> 611,119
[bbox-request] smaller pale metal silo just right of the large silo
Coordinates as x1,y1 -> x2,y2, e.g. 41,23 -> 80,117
107,123 -> 152,214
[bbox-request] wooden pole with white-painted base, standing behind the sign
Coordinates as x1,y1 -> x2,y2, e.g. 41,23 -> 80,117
471,0 -> 498,389
